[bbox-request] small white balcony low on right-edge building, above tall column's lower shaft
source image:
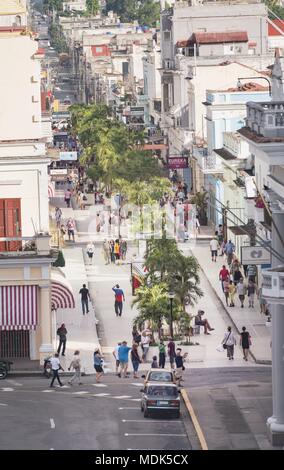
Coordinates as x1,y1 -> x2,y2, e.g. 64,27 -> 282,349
262,266 -> 284,304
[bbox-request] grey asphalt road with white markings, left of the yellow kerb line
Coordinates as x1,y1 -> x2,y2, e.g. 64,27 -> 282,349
0,375 -> 191,450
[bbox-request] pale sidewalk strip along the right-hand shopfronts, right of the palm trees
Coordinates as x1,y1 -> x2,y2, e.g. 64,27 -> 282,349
190,239 -> 271,364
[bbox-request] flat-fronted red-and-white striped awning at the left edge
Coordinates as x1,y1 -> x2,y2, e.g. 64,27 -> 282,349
0,286 -> 38,330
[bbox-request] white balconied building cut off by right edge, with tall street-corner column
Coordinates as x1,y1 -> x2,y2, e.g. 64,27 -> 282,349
239,49 -> 284,446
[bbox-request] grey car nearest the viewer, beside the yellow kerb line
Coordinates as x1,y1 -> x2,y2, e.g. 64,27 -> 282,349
141,382 -> 180,418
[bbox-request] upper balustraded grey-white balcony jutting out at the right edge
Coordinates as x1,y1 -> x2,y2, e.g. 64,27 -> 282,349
246,101 -> 284,139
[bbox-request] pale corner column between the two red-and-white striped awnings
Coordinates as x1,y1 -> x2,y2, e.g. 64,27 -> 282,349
39,285 -> 53,364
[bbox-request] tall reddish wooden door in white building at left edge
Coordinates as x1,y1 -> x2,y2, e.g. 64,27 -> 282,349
0,198 -> 22,251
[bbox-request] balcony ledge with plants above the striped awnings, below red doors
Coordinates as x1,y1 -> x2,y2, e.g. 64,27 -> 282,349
0,233 -> 57,260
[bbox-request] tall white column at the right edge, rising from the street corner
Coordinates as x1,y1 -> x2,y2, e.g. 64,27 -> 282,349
267,211 -> 284,446
